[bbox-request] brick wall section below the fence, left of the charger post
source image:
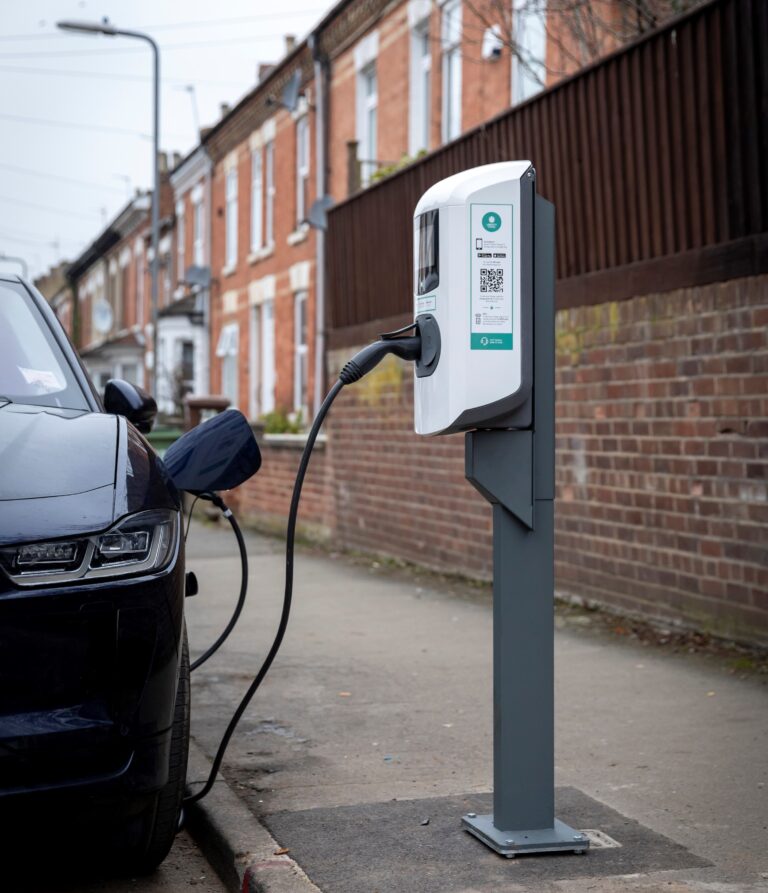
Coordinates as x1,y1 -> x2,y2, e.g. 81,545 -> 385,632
328,350 -> 491,577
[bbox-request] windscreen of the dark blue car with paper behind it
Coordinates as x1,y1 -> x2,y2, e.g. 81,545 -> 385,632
0,282 -> 89,409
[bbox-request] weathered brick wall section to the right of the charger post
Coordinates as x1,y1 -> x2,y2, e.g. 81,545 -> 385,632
556,277 -> 768,638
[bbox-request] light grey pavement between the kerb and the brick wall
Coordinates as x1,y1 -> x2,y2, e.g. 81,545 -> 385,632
183,524 -> 768,893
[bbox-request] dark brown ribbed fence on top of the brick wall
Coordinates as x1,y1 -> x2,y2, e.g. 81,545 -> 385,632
327,0 -> 768,344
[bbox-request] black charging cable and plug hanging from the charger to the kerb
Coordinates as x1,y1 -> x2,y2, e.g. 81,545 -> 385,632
182,332 -> 421,806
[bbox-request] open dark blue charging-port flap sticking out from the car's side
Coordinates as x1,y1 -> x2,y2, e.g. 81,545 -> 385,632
163,409 -> 261,493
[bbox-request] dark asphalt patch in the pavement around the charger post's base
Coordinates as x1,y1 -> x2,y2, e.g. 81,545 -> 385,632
264,788 -> 710,893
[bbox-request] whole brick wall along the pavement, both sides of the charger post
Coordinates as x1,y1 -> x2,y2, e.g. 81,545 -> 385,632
236,277 -> 768,641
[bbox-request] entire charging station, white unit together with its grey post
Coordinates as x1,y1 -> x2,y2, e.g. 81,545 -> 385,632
414,161 -> 589,857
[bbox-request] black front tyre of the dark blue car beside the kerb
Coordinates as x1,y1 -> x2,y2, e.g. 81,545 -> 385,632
120,627 -> 190,874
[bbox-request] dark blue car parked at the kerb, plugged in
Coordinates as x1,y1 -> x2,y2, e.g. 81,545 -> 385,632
0,275 -> 189,871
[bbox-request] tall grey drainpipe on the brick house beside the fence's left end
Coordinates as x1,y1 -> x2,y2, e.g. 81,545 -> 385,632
307,31 -> 330,415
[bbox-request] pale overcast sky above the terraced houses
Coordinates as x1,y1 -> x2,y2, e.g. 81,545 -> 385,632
0,0 -> 331,276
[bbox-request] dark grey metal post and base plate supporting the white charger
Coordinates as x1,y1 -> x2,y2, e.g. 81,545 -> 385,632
462,196 -> 589,857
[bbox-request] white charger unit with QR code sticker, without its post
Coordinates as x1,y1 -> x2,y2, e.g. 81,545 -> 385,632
414,161 -> 536,434
